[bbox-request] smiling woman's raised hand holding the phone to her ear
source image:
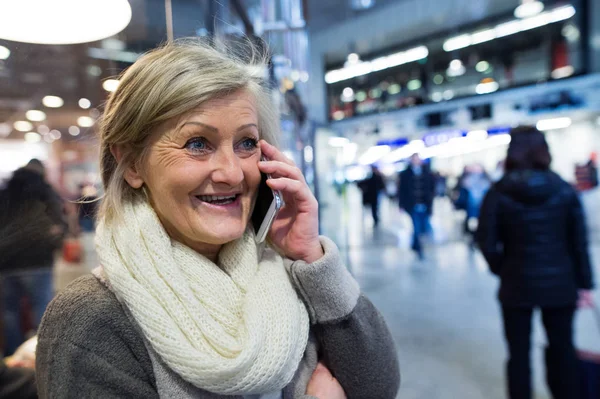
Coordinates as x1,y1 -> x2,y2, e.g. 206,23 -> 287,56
258,140 -> 323,263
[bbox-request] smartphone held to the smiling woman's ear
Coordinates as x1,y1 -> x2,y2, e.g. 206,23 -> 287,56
252,157 -> 284,243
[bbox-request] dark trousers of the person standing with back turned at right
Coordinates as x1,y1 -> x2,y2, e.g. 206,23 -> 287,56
502,306 -> 579,399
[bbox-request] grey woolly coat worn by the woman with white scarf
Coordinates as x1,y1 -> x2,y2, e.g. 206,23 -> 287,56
36,238 -> 400,399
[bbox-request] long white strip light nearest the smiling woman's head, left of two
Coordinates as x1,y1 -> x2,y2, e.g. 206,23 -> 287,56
325,46 -> 429,84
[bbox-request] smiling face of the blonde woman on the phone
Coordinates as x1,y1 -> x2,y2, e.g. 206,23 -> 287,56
137,91 -> 260,253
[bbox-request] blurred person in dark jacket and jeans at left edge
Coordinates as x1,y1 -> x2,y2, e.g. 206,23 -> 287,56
0,159 -> 67,355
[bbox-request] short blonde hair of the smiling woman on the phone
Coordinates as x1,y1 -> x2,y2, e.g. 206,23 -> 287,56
98,39 -> 279,221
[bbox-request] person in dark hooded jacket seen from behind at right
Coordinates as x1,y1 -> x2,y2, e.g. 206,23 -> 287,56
476,127 -> 593,399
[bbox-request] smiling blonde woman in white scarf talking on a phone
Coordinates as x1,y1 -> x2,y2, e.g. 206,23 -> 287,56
32,41 -> 399,399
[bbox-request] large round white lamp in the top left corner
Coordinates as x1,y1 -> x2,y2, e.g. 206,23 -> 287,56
0,0 -> 131,44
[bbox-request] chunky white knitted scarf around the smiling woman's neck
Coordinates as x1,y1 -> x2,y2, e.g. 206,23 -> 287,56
96,202 -> 310,395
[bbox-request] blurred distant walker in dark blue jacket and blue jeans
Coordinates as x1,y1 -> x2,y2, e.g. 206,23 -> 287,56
398,154 -> 435,259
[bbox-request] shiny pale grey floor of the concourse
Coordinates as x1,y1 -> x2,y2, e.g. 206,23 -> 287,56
322,193 -> 600,399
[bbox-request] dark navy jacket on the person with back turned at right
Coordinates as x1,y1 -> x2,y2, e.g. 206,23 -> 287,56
476,171 -> 593,306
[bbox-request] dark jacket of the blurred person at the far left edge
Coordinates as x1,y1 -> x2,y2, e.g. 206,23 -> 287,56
0,168 -> 67,272
